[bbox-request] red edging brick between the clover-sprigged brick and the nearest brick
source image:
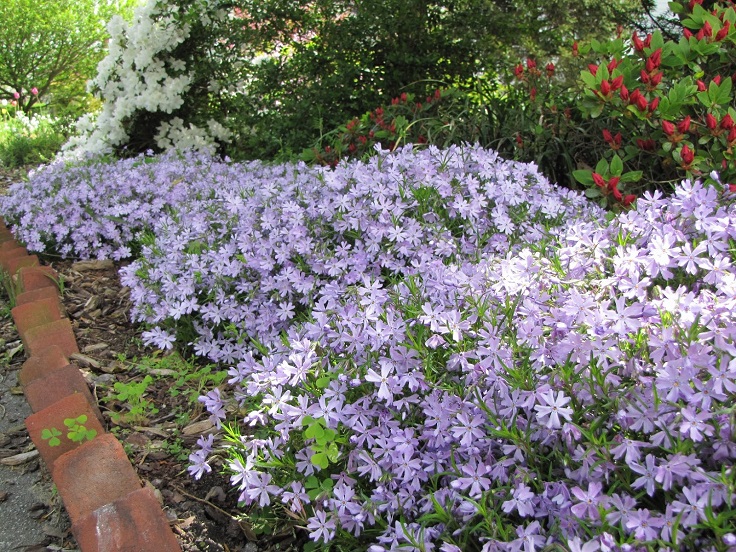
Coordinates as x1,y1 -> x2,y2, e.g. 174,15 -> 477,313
51,433 -> 141,524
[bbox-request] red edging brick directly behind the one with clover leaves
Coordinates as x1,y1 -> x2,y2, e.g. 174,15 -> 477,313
23,364 -> 104,424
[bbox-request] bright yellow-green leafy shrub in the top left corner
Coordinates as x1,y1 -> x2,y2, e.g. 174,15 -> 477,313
0,0 -> 137,118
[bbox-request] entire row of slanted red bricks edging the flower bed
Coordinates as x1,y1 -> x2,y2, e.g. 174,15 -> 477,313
0,217 -> 181,552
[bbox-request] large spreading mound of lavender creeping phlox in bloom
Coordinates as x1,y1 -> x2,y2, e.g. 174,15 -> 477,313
2,146 -> 736,552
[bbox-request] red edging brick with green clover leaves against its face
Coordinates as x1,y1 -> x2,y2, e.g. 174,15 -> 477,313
26,393 -> 105,469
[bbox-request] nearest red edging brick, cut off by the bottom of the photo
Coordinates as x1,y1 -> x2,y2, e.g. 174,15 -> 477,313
72,487 -> 181,552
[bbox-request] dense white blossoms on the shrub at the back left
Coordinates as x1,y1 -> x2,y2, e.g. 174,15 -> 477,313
63,0 -> 230,158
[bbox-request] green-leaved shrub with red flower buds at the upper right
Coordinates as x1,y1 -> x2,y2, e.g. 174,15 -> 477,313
575,0 -> 736,205
